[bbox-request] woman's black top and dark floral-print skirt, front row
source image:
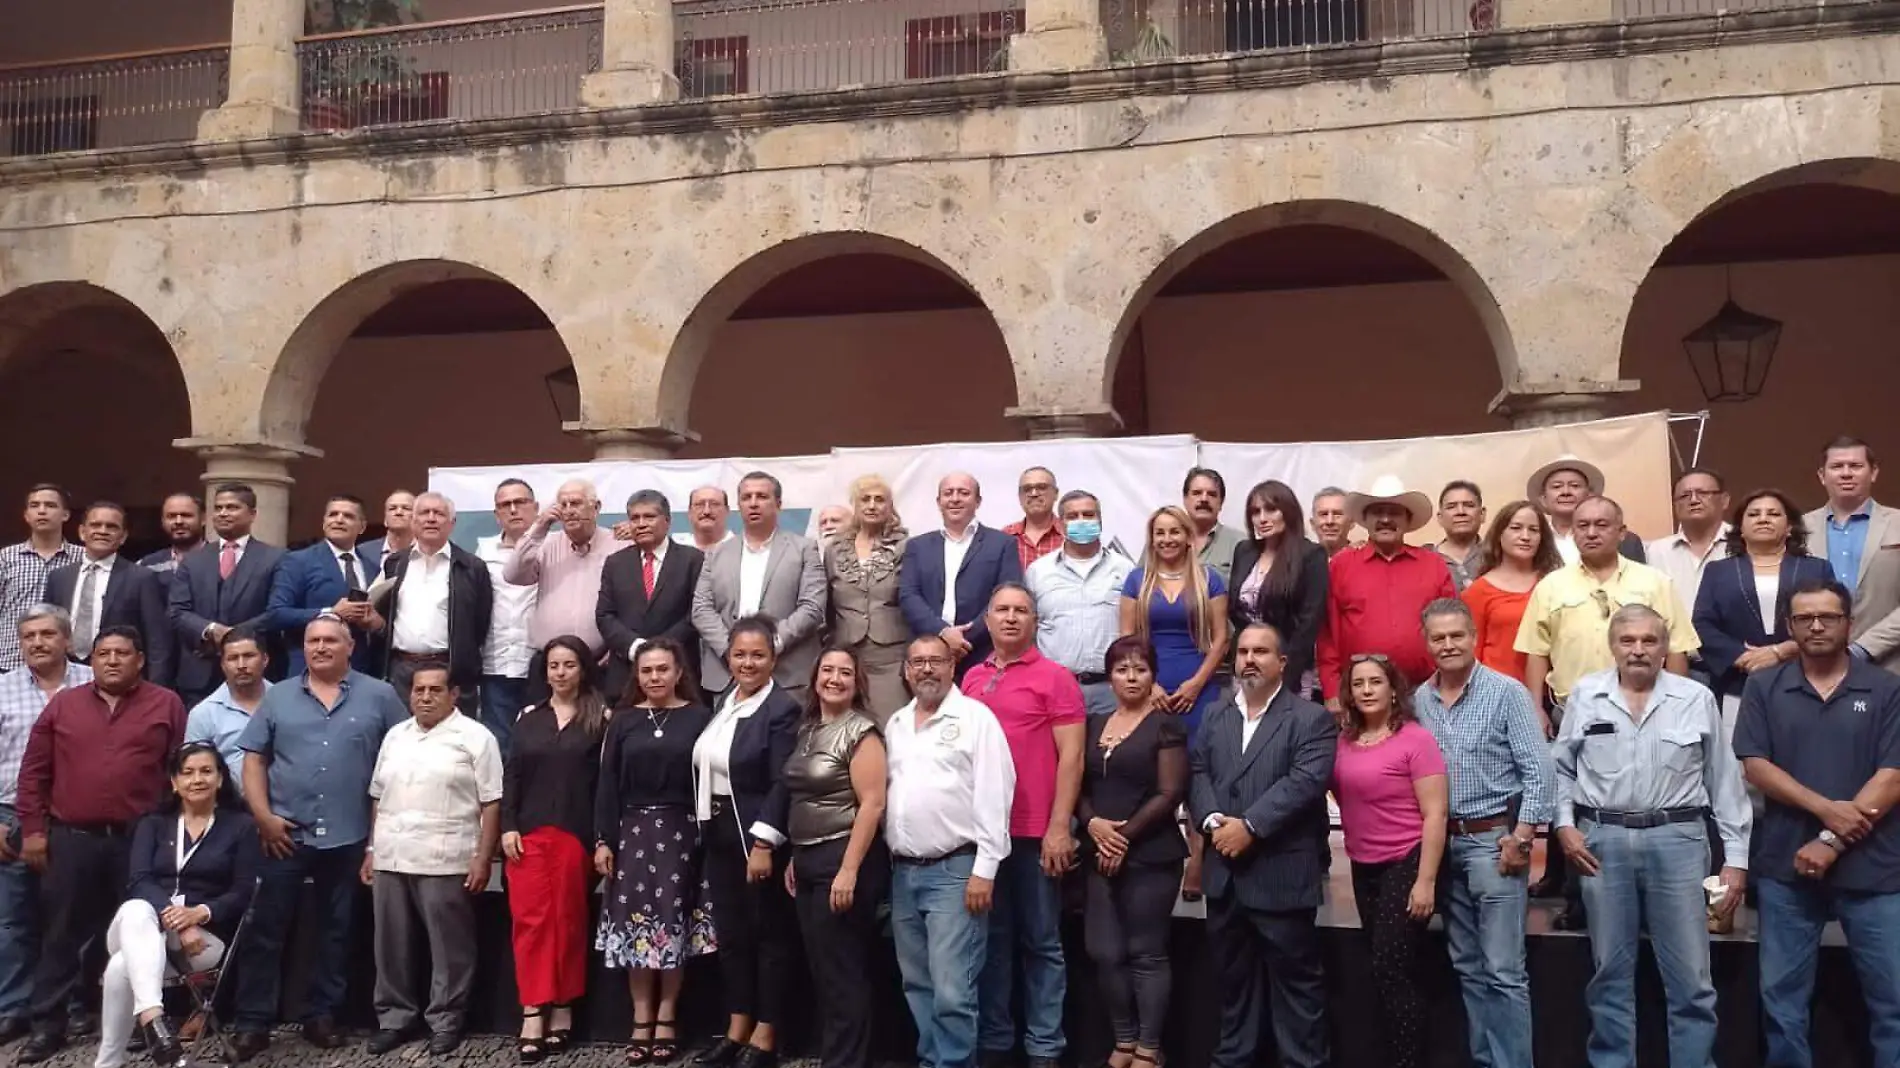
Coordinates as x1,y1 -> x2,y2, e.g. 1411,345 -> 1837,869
595,705 -> 716,971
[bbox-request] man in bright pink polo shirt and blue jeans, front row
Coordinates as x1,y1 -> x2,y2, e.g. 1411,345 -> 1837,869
963,582 -> 1087,1068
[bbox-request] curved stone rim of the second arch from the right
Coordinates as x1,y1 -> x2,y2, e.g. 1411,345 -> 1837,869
1100,200 -> 1518,401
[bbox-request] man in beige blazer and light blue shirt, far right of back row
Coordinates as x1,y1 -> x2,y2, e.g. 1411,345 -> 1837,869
1803,437 -> 1900,675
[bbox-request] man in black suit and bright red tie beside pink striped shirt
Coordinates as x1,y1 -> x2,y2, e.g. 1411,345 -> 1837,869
595,490 -> 705,703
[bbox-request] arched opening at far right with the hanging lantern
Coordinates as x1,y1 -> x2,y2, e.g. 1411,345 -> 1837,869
1623,162 -> 1900,505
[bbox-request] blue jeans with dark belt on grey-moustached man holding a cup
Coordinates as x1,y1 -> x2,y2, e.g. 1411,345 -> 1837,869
1571,821 -> 1716,1068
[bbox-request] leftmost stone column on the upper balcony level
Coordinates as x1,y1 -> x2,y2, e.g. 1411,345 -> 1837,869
198,0 -> 304,141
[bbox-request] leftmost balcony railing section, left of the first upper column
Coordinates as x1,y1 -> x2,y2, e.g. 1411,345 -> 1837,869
0,44 -> 230,156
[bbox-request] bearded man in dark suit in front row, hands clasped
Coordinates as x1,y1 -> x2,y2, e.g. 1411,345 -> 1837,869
1188,623 -> 1340,1068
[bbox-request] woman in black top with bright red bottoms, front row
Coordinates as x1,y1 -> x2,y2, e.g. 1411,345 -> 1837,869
502,635 -> 608,1064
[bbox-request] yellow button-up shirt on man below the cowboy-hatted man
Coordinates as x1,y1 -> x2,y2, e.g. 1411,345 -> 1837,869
1514,557 -> 1702,701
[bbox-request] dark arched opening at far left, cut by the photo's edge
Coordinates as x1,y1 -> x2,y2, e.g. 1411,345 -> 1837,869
0,281 -> 201,553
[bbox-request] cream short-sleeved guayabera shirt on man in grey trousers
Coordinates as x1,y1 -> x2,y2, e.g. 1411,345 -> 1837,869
369,713 -> 502,876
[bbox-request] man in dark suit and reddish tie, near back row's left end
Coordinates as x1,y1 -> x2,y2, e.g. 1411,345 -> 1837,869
171,483 -> 285,707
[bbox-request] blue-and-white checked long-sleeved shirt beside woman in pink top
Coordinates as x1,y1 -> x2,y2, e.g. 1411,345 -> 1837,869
1412,663 -> 1556,823
